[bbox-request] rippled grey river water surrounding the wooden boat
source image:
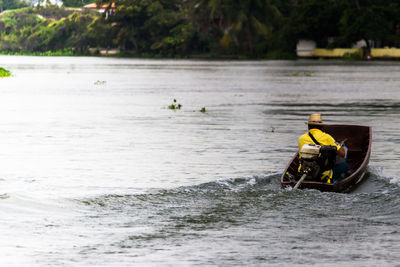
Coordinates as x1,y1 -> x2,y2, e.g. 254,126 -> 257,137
0,56 -> 400,266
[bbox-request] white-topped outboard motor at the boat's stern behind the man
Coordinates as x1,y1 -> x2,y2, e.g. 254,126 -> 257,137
299,144 -> 337,180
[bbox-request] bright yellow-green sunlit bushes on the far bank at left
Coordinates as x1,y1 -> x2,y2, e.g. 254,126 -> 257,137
0,6 -> 111,53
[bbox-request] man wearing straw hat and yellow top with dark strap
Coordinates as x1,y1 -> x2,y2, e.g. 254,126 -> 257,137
299,114 -> 349,183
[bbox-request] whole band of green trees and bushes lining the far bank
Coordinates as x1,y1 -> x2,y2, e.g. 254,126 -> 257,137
0,0 -> 400,60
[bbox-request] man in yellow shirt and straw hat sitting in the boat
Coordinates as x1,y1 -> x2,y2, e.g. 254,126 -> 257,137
299,114 -> 349,183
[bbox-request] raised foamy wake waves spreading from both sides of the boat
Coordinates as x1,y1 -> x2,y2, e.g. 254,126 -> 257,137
79,167 -> 400,209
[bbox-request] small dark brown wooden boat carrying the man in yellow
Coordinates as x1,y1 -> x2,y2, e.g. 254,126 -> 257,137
281,125 -> 372,192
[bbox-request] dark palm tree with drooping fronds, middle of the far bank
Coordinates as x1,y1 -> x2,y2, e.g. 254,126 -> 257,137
195,0 -> 283,55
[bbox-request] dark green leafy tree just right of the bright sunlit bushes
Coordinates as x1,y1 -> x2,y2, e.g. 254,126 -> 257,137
99,0 -> 195,56
